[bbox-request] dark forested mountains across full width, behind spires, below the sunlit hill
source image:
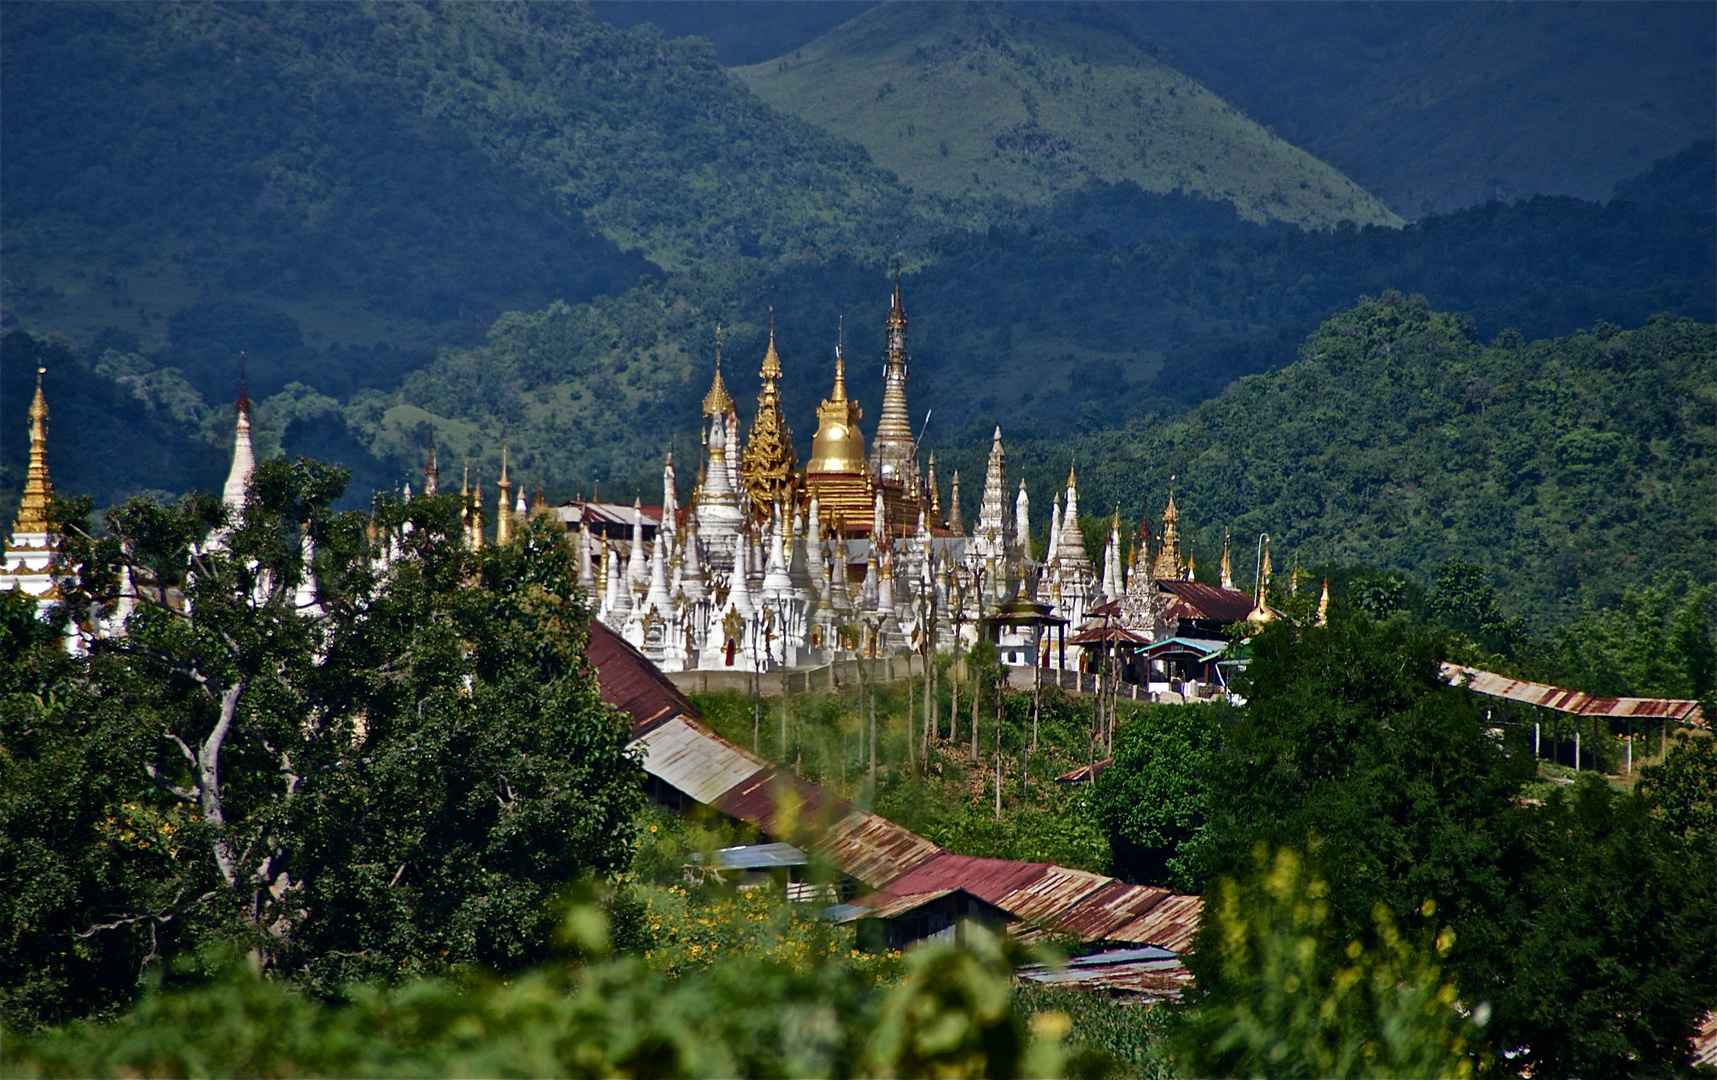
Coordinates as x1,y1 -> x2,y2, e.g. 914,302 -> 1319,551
0,5 -> 1717,628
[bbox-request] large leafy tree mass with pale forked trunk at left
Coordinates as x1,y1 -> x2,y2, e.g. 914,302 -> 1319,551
0,460 -> 639,1027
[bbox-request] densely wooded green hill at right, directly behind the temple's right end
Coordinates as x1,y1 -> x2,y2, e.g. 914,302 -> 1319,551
1010,294 -> 1717,630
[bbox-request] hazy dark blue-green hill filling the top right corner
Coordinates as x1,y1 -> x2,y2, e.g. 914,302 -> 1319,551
1114,0 -> 1717,216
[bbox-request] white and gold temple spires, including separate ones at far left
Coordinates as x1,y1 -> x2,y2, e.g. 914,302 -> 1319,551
0,275 -> 1277,678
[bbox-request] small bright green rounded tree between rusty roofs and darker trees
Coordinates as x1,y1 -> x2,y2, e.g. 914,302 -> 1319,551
1092,706 -> 1223,893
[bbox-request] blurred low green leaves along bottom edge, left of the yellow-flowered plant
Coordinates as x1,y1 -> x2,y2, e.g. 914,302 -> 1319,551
7,907 -> 1068,1077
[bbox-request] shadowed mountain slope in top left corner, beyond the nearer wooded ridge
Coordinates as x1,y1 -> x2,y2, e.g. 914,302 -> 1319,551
0,3 -> 917,362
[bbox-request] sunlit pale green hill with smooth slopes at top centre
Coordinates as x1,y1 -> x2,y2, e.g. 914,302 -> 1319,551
737,3 -> 1399,228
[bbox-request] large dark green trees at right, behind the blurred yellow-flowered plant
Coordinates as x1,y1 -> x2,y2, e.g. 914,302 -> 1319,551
1190,613 -> 1717,1075
